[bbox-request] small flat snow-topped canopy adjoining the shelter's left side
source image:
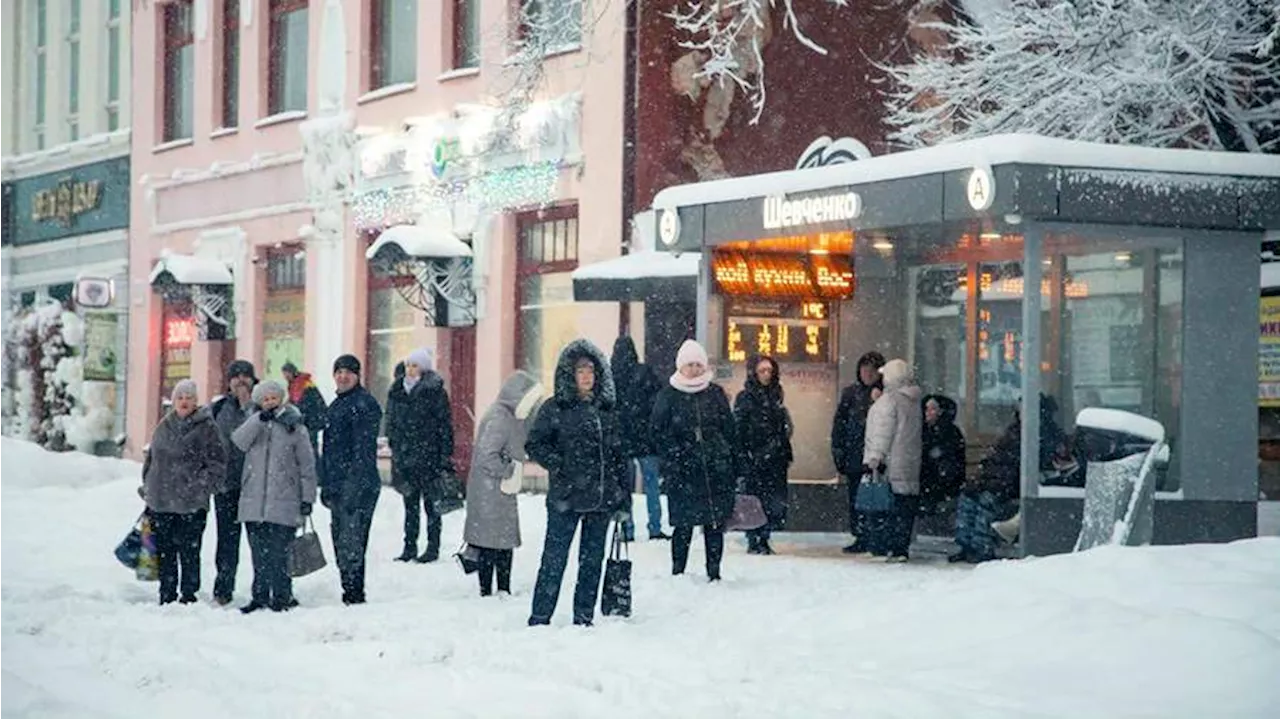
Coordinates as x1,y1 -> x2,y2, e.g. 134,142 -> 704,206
573,251 -> 701,302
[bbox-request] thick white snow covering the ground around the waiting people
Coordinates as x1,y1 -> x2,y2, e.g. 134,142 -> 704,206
0,439 -> 1280,719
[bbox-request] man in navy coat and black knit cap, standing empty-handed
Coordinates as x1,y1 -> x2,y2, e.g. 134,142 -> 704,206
320,354 -> 383,604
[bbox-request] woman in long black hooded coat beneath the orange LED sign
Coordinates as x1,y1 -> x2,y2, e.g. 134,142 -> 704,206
733,356 -> 794,554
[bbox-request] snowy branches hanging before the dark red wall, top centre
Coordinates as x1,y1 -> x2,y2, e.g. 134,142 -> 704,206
668,0 -> 849,124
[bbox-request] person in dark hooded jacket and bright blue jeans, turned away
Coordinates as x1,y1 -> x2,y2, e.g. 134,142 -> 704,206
609,335 -> 671,541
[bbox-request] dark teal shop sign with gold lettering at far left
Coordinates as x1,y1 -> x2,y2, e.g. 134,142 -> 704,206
13,157 -> 129,244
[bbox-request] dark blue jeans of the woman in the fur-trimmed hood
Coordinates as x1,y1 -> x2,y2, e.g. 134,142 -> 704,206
530,509 -> 611,624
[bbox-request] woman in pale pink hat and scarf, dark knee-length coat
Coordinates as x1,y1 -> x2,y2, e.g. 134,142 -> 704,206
652,339 -> 742,582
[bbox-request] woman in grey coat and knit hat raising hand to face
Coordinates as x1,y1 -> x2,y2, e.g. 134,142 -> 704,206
232,380 -> 316,614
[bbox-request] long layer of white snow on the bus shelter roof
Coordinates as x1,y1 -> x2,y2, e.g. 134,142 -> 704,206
653,133 -> 1280,210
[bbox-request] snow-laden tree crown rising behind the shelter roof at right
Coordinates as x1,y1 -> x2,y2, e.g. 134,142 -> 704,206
887,0 -> 1280,152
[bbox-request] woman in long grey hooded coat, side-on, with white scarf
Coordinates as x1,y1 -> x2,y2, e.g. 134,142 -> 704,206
462,370 -> 543,596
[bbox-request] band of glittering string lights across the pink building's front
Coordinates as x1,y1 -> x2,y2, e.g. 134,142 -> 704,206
352,161 -> 561,229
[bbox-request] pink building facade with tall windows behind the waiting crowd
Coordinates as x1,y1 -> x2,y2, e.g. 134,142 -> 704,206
127,0 -> 625,463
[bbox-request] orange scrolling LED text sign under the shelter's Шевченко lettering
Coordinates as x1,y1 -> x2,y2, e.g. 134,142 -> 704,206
712,252 -> 854,299
